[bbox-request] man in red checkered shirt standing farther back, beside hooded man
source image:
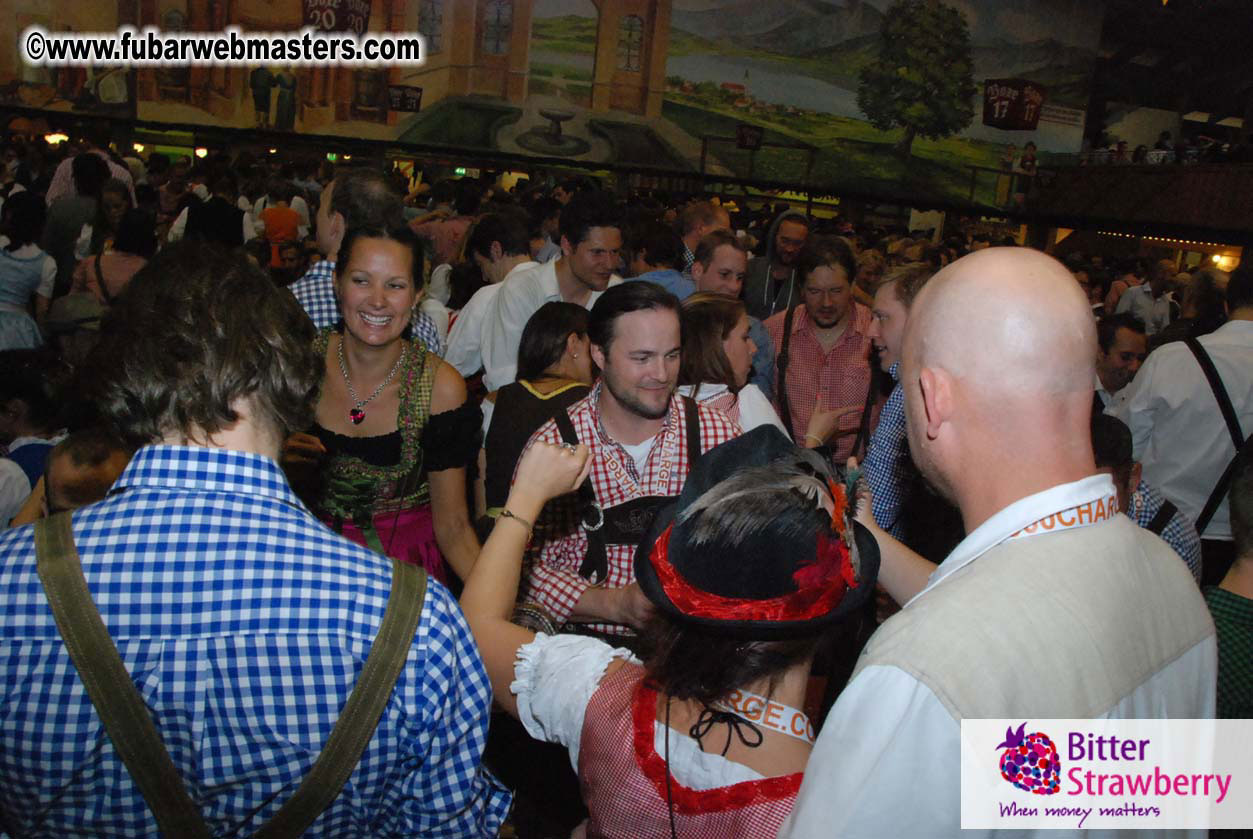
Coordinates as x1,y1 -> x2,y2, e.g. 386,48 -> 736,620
764,237 -> 871,463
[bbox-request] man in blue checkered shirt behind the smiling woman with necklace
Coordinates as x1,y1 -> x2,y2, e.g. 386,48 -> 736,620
288,169 -> 446,356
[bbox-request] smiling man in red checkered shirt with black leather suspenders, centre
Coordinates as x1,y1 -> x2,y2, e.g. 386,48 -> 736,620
513,283 -> 741,635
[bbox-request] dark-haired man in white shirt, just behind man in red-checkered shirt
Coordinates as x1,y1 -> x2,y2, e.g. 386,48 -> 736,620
482,190 -> 623,391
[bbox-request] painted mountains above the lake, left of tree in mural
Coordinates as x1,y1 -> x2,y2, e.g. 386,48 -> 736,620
670,0 -> 883,55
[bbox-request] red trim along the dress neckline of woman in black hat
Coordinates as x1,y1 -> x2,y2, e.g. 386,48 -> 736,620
632,680 -> 804,815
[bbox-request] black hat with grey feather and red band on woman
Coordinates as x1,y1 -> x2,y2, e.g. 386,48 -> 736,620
635,426 -> 878,640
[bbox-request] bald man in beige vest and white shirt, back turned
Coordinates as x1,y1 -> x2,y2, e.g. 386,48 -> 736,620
779,248 -> 1217,839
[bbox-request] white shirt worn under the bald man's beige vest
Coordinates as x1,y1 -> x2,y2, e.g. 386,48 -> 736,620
779,475 -> 1215,839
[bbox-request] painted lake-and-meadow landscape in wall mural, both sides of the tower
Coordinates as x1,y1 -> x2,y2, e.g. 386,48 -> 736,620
530,0 -> 1103,203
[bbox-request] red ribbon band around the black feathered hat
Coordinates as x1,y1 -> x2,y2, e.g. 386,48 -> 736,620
649,525 -> 858,621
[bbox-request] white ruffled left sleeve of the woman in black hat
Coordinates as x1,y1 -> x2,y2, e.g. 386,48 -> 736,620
509,632 -> 635,771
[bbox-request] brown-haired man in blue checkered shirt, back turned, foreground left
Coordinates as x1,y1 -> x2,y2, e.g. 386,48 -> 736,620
0,243 -> 510,839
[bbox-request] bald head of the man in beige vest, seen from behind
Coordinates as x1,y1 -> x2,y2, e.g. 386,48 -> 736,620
901,248 -> 1096,515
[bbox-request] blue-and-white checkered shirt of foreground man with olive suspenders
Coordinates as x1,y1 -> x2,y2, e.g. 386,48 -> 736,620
0,446 -> 510,839
